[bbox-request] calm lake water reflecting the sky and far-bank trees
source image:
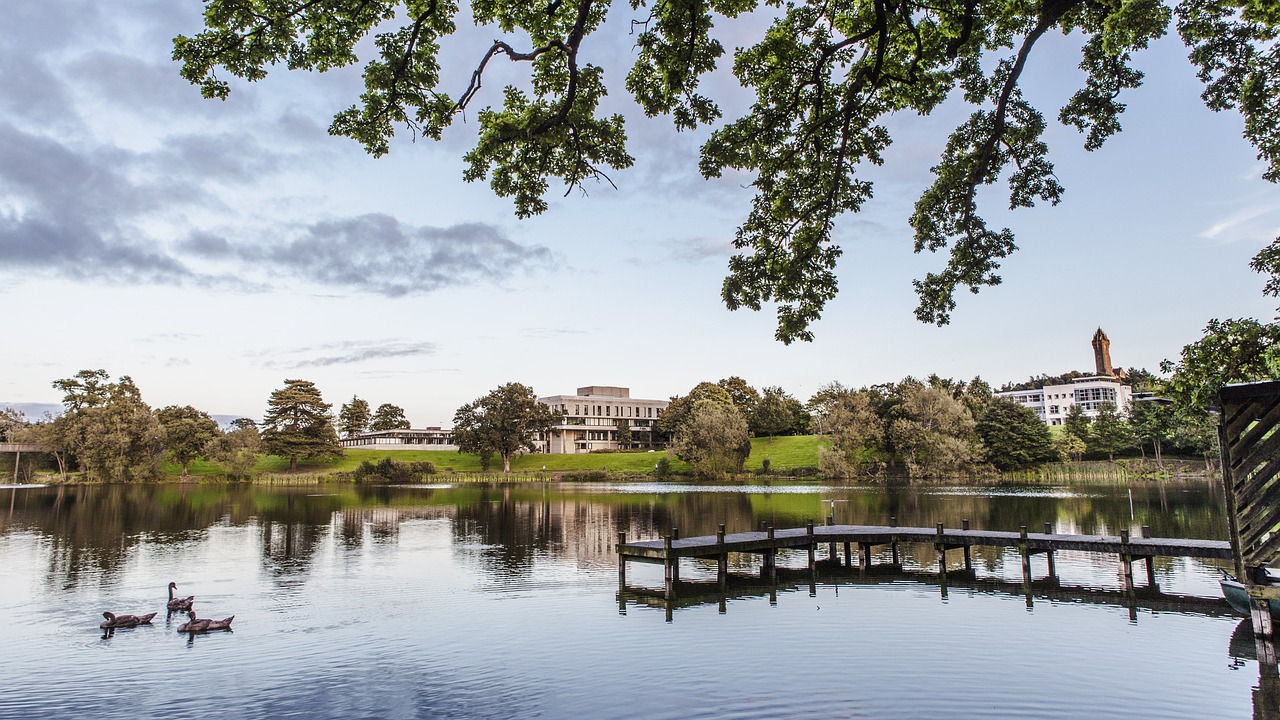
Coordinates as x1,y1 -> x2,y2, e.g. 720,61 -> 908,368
0,483 -> 1271,720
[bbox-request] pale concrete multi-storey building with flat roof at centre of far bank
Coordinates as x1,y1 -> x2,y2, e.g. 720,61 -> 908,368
538,386 -> 668,455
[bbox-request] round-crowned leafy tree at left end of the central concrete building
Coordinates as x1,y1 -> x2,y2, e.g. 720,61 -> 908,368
453,383 -> 557,473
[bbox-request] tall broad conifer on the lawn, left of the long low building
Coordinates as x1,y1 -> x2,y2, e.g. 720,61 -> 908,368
261,380 -> 342,473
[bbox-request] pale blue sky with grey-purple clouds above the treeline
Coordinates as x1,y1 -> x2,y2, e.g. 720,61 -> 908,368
0,0 -> 1280,427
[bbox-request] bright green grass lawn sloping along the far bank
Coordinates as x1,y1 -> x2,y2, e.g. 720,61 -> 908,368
160,436 -> 818,477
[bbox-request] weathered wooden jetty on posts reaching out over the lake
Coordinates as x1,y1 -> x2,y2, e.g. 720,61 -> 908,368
617,520 -> 1233,596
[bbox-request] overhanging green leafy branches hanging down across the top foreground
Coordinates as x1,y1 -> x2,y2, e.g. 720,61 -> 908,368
174,0 -> 1280,343
